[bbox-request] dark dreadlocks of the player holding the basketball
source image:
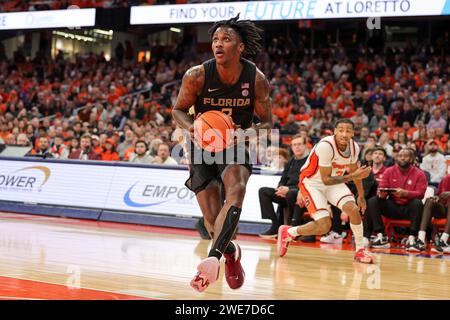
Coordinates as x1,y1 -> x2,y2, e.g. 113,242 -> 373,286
208,13 -> 263,59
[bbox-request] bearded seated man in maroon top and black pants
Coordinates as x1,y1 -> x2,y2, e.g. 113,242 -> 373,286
364,149 -> 427,249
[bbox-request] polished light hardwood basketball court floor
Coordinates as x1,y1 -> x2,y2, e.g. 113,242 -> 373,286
0,213 -> 450,300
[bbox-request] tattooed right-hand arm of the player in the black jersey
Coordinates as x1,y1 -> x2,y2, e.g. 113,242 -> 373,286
251,68 -> 273,130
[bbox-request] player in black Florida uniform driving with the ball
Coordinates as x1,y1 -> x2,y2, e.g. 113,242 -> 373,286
172,15 -> 272,292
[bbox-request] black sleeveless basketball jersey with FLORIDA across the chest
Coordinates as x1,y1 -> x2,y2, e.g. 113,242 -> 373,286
194,58 -> 256,129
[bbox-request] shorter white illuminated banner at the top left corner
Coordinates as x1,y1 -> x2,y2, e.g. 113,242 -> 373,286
0,9 -> 95,30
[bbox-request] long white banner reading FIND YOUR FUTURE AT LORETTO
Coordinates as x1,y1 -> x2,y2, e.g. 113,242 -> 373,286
130,0 -> 450,25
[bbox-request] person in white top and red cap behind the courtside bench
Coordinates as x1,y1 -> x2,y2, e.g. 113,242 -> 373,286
420,140 -> 447,188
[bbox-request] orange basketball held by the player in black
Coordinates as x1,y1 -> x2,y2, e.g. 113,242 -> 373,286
194,110 -> 234,152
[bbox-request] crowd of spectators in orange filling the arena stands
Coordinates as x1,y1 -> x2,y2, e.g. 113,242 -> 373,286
0,36 -> 450,170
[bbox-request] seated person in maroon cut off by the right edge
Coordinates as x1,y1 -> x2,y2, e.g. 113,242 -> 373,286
410,174 -> 450,254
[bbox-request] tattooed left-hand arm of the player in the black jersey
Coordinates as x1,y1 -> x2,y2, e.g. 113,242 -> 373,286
172,65 -> 205,130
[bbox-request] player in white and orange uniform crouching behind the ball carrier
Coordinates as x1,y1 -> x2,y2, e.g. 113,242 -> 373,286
278,119 -> 373,263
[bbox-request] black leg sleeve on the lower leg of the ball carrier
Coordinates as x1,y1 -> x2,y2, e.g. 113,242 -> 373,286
208,206 -> 242,260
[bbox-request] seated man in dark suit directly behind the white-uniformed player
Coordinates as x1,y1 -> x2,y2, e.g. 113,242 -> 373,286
259,135 -> 309,238
